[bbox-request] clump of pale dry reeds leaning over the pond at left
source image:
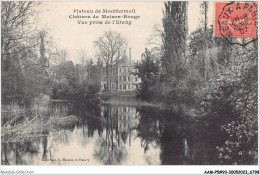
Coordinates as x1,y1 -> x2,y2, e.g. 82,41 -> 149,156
1,110 -> 80,143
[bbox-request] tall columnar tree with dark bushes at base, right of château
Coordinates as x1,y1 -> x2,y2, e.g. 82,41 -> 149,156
137,2 -> 196,106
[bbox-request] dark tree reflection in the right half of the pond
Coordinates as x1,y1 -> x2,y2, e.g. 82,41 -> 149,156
138,107 -> 221,165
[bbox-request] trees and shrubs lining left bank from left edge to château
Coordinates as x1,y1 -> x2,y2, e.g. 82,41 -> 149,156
1,1 -> 102,106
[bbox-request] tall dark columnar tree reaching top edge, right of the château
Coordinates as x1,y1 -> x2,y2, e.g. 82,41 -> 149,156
162,1 -> 188,79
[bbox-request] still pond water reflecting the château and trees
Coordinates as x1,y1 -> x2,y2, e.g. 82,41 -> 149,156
1,98 -> 254,165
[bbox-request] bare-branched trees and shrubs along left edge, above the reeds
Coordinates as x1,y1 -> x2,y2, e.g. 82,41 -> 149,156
1,1 -> 49,105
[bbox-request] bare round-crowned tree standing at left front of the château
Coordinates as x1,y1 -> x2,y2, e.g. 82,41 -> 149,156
94,31 -> 127,90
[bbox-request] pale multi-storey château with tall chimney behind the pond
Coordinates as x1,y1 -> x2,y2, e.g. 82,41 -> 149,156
101,49 -> 141,92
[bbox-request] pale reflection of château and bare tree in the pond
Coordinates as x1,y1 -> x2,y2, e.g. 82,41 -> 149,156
94,105 -> 139,165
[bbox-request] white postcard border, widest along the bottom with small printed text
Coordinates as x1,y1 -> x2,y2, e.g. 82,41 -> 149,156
0,0 -> 260,174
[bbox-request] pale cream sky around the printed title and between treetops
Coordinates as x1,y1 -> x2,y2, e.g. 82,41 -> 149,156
39,2 -> 214,63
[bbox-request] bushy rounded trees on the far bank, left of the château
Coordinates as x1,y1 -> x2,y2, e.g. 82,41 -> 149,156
52,60 -> 100,99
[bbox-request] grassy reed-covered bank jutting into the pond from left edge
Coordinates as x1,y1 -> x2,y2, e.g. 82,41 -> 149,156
1,106 -> 79,143
